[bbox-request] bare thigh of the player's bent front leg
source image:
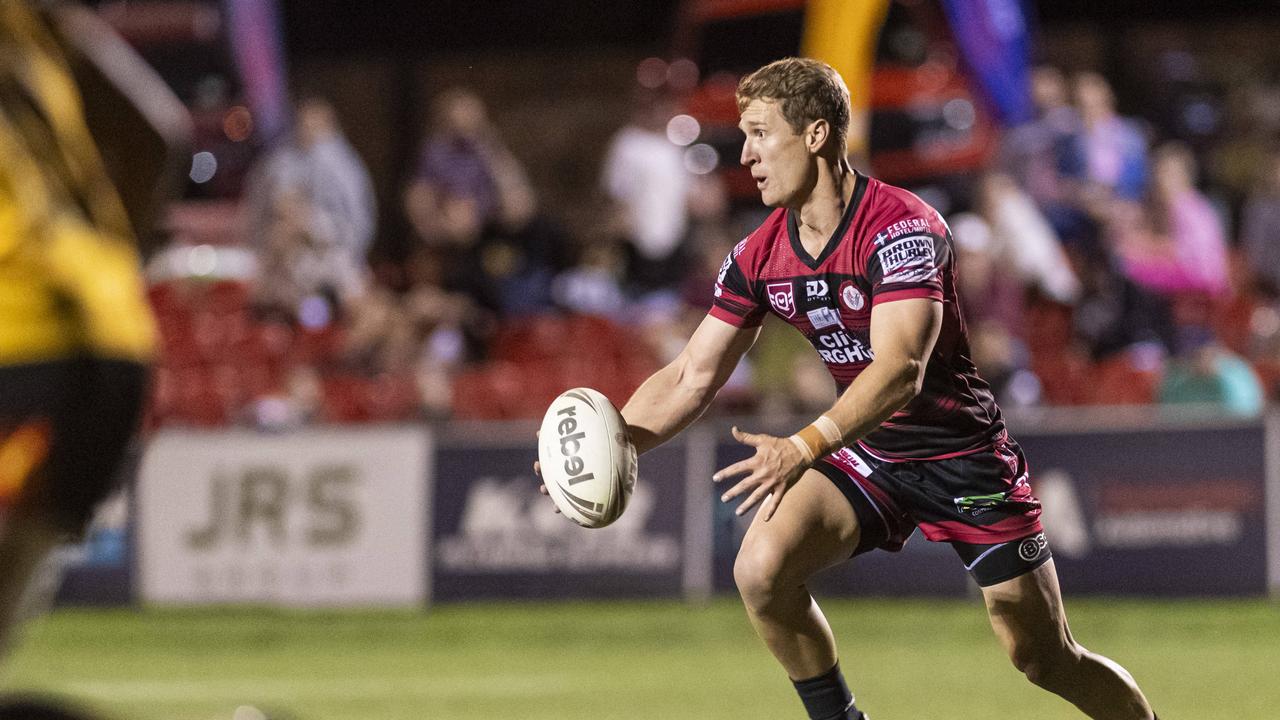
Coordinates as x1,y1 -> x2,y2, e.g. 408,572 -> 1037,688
733,470 -> 860,584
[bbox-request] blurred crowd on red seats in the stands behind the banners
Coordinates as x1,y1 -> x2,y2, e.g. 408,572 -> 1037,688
150,57 -> 1280,428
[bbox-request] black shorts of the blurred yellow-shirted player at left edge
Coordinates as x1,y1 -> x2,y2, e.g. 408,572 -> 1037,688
0,357 -> 147,537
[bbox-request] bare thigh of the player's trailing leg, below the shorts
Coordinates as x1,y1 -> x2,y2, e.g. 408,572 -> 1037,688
982,560 -> 1073,665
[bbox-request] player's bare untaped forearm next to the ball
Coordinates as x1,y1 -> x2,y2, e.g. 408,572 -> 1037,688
622,357 -> 723,452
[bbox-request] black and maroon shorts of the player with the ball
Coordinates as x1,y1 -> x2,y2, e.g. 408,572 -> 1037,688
814,437 -> 1051,587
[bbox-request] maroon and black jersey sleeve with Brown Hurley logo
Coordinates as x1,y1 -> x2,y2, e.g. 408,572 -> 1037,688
863,202 -> 951,306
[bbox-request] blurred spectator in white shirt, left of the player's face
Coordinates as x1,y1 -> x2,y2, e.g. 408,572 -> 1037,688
603,91 -> 692,292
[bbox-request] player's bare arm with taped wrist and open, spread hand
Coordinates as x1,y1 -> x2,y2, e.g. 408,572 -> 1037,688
713,299 -> 942,520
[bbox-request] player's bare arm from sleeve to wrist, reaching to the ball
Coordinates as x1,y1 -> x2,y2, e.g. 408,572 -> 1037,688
622,315 -> 760,452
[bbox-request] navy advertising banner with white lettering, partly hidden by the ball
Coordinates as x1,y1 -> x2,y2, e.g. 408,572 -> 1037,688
431,433 -> 686,601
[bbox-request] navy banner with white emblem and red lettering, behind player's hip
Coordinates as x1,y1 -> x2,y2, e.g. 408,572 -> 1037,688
1018,424 -> 1267,596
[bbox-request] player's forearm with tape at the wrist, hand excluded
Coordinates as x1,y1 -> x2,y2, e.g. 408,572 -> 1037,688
791,359 -> 924,461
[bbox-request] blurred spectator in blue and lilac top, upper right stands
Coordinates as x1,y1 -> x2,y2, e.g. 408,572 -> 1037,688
1066,73 -> 1147,207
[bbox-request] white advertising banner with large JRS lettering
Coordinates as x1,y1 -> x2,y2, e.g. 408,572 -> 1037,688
137,428 -> 429,606
